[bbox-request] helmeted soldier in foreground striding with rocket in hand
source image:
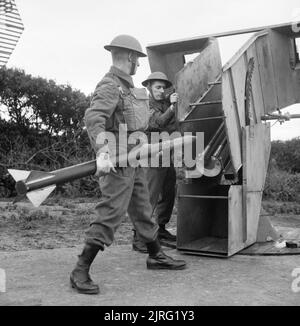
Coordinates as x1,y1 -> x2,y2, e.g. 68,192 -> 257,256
70,35 -> 186,294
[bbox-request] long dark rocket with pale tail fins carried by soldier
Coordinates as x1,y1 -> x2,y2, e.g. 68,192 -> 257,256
8,136 -> 196,207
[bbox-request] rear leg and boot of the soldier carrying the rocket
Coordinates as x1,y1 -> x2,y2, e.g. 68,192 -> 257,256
70,168 -> 134,294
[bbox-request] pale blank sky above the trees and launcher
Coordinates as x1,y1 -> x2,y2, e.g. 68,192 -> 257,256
7,0 -> 300,140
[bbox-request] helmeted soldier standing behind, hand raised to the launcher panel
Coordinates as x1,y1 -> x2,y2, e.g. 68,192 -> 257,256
132,72 -> 178,253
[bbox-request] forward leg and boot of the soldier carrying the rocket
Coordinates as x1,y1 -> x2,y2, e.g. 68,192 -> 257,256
128,168 -> 186,269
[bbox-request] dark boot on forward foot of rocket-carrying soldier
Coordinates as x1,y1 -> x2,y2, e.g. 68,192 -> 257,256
146,240 -> 186,270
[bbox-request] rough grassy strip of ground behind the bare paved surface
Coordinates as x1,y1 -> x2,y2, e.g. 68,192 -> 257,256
0,198 -> 300,251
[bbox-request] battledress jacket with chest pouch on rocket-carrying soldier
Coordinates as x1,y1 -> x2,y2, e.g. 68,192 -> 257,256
84,66 -> 150,155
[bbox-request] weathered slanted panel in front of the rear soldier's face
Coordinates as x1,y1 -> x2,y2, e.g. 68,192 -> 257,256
176,40 -> 222,120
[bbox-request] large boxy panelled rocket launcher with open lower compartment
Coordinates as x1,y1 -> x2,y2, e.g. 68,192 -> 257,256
147,23 -> 300,257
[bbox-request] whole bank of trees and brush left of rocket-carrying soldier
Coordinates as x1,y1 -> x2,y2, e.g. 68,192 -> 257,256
0,68 -> 96,196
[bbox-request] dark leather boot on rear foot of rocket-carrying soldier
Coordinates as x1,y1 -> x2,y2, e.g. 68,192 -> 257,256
70,244 -> 100,294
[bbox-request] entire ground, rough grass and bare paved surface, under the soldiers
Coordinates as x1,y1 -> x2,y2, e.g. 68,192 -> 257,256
0,199 -> 300,306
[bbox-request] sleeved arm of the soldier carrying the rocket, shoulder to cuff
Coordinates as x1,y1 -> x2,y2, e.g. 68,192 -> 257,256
84,80 -> 119,153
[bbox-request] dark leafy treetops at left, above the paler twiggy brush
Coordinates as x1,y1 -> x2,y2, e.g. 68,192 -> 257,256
0,68 -> 89,134
